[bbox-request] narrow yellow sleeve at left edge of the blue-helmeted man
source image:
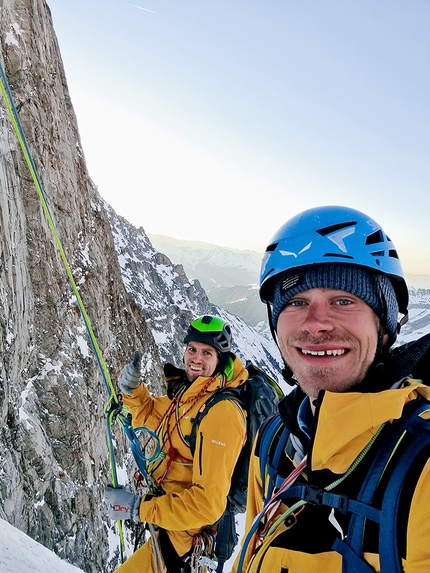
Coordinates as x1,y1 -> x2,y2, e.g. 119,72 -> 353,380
231,438 -> 263,573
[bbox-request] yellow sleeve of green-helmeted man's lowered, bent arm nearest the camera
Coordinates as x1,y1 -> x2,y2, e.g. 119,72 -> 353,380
139,400 -> 246,531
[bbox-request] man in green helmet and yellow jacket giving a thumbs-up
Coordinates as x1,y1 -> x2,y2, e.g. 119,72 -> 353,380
105,315 -> 248,573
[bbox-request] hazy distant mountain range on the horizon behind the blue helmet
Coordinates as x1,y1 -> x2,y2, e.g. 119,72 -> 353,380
147,233 -> 430,333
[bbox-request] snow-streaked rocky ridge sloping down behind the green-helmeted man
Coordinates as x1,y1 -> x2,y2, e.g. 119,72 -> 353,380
105,205 -> 283,384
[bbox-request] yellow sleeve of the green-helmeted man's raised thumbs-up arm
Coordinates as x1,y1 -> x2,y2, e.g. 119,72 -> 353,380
122,384 -> 170,430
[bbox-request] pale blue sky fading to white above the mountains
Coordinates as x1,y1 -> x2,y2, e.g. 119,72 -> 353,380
47,0 -> 430,274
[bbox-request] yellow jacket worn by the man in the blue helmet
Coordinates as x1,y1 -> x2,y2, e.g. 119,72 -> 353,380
233,379 -> 430,573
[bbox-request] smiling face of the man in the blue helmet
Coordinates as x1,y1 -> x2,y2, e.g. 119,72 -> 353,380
277,288 -> 382,400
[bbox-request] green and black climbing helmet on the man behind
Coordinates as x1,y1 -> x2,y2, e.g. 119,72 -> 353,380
184,314 -> 232,352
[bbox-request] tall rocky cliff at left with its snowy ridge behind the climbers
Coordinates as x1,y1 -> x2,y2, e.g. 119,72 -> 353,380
0,0 -> 282,573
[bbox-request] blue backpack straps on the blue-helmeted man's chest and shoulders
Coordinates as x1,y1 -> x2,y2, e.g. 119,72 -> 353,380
259,399 -> 430,573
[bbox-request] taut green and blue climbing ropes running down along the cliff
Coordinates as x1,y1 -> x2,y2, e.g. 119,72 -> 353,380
0,62 -> 159,562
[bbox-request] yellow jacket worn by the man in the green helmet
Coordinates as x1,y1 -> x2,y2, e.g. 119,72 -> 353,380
123,356 -> 248,555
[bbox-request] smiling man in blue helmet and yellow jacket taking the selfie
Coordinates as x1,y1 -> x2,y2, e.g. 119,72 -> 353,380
234,207 -> 430,573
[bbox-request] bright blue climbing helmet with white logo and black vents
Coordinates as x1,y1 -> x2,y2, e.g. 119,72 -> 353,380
260,206 -> 409,324
